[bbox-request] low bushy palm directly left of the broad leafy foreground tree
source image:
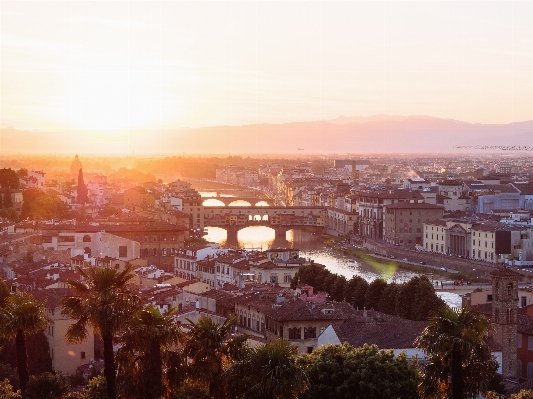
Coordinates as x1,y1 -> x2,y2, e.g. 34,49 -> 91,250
225,339 -> 309,399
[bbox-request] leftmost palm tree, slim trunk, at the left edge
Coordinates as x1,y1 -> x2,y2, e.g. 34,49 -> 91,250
0,292 -> 48,399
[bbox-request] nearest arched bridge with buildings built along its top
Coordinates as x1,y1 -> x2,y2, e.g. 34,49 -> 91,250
204,206 -> 327,246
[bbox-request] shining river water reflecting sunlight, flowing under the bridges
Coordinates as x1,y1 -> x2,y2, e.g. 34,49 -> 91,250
201,192 -> 461,307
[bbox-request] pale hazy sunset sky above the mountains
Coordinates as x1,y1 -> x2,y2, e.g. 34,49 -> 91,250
0,1 -> 533,130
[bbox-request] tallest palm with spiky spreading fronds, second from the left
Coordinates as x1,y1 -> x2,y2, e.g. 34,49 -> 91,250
61,265 -> 140,399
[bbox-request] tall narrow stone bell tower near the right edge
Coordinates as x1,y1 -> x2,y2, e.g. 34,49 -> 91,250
490,267 -> 520,378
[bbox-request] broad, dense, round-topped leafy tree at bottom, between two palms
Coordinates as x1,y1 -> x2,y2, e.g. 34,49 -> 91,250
298,343 -> 418,399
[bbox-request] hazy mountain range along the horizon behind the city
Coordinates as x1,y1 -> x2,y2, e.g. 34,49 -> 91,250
0,115 -> 533,154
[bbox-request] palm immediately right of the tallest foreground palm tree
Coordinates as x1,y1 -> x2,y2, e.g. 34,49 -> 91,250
117,305 -> 182,399
